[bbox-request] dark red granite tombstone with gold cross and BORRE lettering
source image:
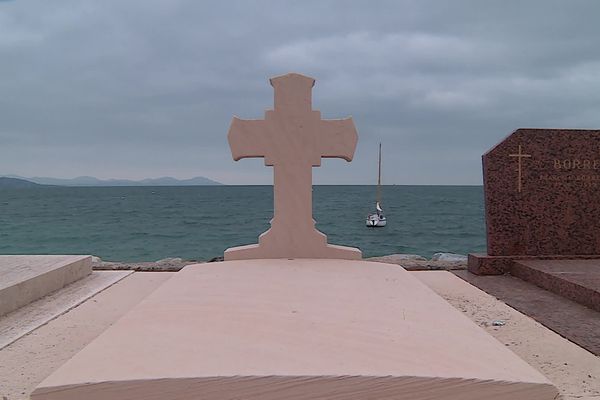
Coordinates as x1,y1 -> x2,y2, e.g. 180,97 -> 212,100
469,129 -> 600,275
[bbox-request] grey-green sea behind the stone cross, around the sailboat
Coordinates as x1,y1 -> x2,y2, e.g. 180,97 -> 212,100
0,185 -> 485,262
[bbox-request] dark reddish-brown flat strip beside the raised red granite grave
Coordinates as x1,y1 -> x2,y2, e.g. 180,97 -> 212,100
453,271 -> 600,356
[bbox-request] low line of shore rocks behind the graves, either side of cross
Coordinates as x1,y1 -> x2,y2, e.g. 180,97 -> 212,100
92,253 -> 467,272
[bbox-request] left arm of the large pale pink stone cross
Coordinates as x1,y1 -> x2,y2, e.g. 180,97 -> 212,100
227,117 -> 266,161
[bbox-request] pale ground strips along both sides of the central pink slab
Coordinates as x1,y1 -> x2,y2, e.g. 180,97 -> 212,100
0,271 -> 600,400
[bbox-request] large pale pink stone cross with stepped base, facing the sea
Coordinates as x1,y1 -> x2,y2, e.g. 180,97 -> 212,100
225,74 -> 361,260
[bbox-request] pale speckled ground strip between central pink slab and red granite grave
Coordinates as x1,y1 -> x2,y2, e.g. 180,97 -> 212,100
412,271 -> 600,400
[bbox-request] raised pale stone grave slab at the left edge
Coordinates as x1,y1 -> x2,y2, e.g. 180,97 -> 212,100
0,255 -> 92,316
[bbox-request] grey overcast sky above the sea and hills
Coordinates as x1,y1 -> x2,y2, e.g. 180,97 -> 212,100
0,0 -> 600,184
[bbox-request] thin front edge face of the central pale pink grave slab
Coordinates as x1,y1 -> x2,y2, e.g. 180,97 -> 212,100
31,375 -> 557,400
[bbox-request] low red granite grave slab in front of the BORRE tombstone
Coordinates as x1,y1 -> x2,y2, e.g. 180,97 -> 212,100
511,260 -> 600,311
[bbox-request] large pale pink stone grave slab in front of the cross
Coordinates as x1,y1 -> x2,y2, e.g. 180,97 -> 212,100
31,259 -> 557,400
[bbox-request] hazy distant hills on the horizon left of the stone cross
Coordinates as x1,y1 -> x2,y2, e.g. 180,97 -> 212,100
2,175 -> 222,186
